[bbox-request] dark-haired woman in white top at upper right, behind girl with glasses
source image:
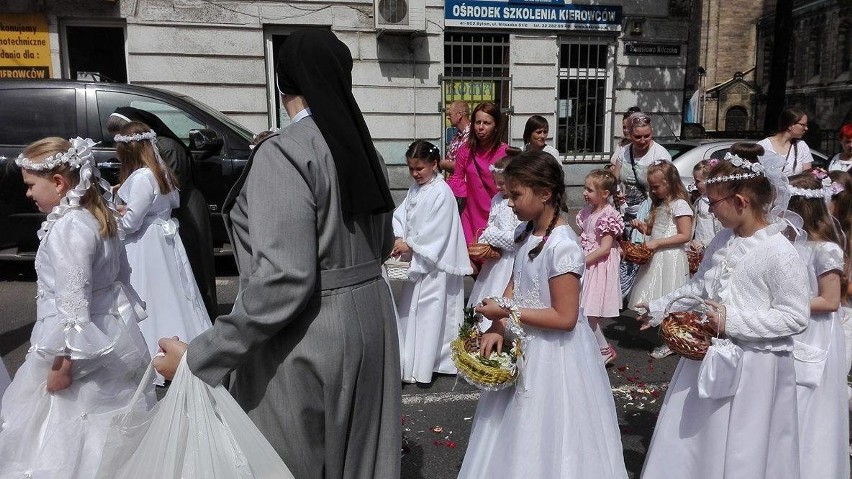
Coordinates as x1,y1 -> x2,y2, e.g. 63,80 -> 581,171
757,108 -> 814,176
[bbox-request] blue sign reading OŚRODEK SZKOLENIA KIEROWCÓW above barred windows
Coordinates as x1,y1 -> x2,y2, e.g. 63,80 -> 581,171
444,0 -> 621,31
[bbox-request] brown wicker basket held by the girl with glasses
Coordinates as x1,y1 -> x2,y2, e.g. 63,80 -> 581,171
660,296 -> 716,361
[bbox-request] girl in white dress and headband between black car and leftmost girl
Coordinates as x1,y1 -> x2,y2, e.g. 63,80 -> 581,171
115,121 -> 212,384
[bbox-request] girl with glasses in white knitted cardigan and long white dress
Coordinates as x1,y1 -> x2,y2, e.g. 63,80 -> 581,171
637,143 -> 810,479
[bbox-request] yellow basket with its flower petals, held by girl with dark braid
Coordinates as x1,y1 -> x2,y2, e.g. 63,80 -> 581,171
450,306 -> 523,391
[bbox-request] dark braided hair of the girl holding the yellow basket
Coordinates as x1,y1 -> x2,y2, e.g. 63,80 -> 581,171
504,151 -> 568,261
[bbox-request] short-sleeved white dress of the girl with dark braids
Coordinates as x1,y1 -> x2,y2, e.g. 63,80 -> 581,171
459,226 -> 627,479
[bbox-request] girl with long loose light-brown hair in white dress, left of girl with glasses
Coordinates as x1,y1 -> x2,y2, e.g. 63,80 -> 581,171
627,161 -> 693,359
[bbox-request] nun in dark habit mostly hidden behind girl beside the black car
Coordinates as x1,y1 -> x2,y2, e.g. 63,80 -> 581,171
107,106 -> 219,320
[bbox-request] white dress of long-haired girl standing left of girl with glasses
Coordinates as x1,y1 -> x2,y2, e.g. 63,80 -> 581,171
627,199 -> 692,309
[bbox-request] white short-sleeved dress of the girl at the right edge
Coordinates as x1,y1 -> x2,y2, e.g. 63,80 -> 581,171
793,241 -> 849,478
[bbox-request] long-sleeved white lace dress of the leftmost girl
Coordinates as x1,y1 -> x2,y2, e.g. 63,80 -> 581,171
0,209 -> 154,479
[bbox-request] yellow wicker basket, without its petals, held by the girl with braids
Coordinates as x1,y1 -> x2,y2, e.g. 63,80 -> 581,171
450,308 -> 521,391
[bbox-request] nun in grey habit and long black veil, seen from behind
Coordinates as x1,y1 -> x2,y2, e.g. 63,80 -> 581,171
155,29 -> 402,479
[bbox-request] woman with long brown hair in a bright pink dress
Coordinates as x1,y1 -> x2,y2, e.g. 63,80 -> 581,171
447,102 -> 507,243
